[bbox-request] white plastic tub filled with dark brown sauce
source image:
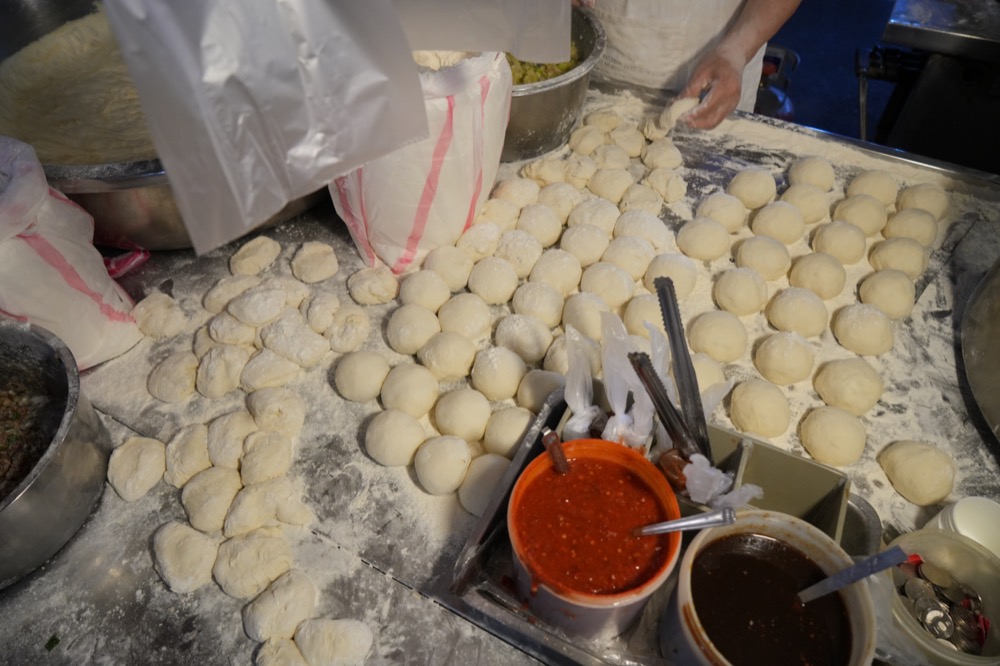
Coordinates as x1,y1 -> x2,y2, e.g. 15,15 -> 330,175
660,511 -> 876,666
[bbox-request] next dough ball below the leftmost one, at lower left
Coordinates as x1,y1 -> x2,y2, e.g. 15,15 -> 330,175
153,522 -> 219,594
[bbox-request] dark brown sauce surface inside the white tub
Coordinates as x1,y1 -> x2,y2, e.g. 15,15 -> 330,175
691,534 -> 851,666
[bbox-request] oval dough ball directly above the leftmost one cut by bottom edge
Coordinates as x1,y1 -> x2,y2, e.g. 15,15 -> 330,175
243,569 -> 319,643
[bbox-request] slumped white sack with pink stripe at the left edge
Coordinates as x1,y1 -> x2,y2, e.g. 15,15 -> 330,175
0,137 -> 142,369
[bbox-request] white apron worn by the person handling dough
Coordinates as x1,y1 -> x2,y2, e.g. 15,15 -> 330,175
591,0 -> 766,111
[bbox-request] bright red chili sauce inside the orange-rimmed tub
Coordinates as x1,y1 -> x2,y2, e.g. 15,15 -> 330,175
516,458 -> 670,594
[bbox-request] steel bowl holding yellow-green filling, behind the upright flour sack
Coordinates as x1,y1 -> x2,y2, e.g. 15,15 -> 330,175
500,9 -> 606,162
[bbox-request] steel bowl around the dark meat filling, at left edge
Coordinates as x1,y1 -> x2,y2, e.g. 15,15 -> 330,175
0,317 -> 111,589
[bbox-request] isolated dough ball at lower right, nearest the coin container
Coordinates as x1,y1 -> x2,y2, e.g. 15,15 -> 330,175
878,440 -> 955,506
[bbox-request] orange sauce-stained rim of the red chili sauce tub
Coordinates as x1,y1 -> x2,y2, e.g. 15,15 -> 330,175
507,439 -> 681,608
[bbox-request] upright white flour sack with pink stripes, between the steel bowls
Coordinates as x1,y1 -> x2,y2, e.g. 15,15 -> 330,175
330,52 -> 512,274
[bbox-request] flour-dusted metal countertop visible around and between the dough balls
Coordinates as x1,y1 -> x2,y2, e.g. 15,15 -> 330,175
0,92 -> 1000,665
